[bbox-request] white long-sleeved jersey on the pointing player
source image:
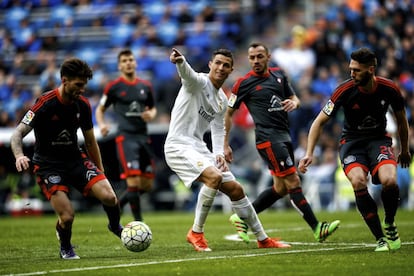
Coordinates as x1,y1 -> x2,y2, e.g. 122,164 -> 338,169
165,58 -> 227,154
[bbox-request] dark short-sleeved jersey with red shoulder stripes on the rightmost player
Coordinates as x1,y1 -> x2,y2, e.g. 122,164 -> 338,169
323,77 -> 404,139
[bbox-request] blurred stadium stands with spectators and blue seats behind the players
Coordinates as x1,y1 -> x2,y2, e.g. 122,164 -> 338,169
0,0 -> 414,216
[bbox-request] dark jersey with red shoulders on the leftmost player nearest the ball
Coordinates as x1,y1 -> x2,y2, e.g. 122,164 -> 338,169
22,89 -> 93,163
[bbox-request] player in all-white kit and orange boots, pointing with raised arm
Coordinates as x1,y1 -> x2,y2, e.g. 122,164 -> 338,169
164,48 -> 290,251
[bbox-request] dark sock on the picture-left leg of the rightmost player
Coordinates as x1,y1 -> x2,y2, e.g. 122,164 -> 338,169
355,188 -> 384,240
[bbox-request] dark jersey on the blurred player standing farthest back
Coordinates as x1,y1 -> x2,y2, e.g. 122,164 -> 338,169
104,77 -> 154,134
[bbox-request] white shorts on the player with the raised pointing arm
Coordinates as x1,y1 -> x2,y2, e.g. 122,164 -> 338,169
164,143 -> 235,187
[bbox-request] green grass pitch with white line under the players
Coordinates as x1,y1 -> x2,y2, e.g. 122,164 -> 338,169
0,210 -> 414,276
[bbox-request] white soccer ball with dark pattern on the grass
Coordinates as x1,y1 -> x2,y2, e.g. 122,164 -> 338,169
121,221 -> 152,252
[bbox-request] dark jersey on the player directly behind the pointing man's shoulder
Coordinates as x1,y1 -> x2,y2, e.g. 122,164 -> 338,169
229,67 -> 295,144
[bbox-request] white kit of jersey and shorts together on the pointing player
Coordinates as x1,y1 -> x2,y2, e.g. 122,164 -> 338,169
164,61 -> 235,187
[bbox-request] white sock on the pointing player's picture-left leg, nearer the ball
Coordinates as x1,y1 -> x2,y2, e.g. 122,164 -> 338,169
193,184 -> 217,233
